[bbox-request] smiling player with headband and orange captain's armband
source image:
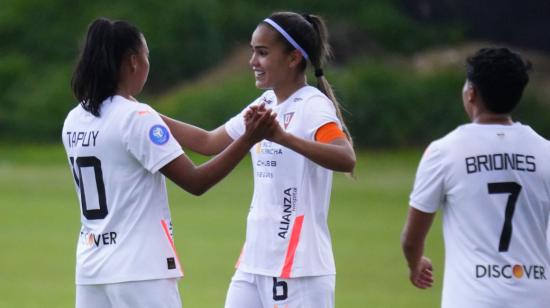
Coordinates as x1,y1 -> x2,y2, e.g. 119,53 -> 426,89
164,12 -> 355,308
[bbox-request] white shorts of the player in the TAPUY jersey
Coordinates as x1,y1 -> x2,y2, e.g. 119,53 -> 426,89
76,279 -> 181,308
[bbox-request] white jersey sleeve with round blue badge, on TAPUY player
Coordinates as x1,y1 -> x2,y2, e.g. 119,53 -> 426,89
122,104 -> 183,173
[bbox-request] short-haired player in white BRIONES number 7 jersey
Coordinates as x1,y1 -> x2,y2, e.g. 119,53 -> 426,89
402,48 -> 550,308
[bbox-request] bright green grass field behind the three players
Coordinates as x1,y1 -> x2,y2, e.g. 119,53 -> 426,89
0,144 -> 443,308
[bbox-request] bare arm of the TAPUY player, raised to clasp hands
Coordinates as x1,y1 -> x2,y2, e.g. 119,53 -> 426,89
160,112 -> 276,195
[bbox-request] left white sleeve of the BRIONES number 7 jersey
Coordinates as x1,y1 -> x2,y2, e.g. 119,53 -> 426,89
410,143 -> 445,213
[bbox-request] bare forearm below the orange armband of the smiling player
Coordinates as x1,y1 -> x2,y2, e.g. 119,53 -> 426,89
268,126 -> 355,172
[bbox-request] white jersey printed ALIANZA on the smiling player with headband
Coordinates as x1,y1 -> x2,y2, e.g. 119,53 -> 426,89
225,86 -> 340,278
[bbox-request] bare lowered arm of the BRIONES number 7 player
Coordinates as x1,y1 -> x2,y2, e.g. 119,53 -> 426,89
401,207 -> 435,289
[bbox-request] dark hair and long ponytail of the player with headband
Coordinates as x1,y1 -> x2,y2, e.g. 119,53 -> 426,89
264,12 -> 353,145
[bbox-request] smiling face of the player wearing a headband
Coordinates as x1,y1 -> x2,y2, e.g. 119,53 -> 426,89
249,24 -> 295,90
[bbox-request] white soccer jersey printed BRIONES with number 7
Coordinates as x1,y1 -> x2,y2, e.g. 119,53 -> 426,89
410,123 -> 550,308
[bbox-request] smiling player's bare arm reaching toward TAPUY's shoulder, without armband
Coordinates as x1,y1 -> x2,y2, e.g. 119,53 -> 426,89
160,115 -> 233,155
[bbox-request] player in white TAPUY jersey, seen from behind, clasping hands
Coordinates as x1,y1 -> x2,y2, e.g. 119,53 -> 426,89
62,19 -> 277,308
